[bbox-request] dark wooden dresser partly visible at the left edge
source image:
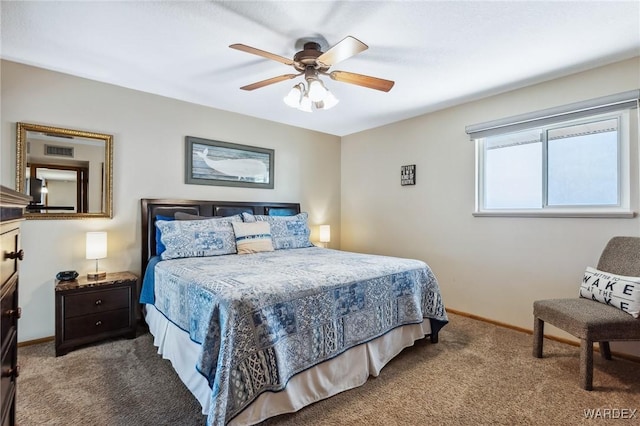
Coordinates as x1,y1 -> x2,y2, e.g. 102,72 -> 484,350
0,186 -> 31,426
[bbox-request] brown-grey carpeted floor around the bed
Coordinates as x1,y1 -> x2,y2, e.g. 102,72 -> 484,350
17,314 -> 640,426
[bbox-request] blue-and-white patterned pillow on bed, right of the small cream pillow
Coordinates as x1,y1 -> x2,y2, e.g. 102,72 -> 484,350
242,212 -> 313,250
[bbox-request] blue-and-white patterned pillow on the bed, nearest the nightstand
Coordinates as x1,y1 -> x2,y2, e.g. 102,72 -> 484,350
156,215 -> 242,260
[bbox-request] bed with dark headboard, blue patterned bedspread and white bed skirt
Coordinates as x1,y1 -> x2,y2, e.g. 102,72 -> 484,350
140,199 -> 448,425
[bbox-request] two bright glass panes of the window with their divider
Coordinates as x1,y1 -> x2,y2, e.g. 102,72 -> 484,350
479,116 -> 621,210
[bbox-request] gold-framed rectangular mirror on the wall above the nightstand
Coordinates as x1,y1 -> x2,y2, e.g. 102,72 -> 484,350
16,123 -> 113,219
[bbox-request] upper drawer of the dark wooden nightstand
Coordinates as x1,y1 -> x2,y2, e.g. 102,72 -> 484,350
64,287 -> 131,318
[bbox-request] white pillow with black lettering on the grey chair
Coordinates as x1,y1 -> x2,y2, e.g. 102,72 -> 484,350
580,268 -> 640,318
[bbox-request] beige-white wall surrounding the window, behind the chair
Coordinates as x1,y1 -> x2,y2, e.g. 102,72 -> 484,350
341,58 -> 640,354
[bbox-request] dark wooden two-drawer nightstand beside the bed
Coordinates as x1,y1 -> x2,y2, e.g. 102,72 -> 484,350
55,272 -> 138,356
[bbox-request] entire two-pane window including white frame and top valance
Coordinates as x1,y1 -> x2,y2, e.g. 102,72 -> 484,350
467,91 -> 639,217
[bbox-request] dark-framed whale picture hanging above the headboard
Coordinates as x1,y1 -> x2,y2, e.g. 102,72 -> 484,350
185,136 -> 275,189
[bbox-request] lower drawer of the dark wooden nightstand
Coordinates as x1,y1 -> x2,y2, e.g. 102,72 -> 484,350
64,308 -> 132,340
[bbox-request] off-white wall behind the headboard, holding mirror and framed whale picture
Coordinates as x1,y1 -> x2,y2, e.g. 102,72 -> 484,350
0,61 -> 340,341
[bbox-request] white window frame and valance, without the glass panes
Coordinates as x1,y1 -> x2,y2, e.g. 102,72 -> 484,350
466,90 -> 640,218
